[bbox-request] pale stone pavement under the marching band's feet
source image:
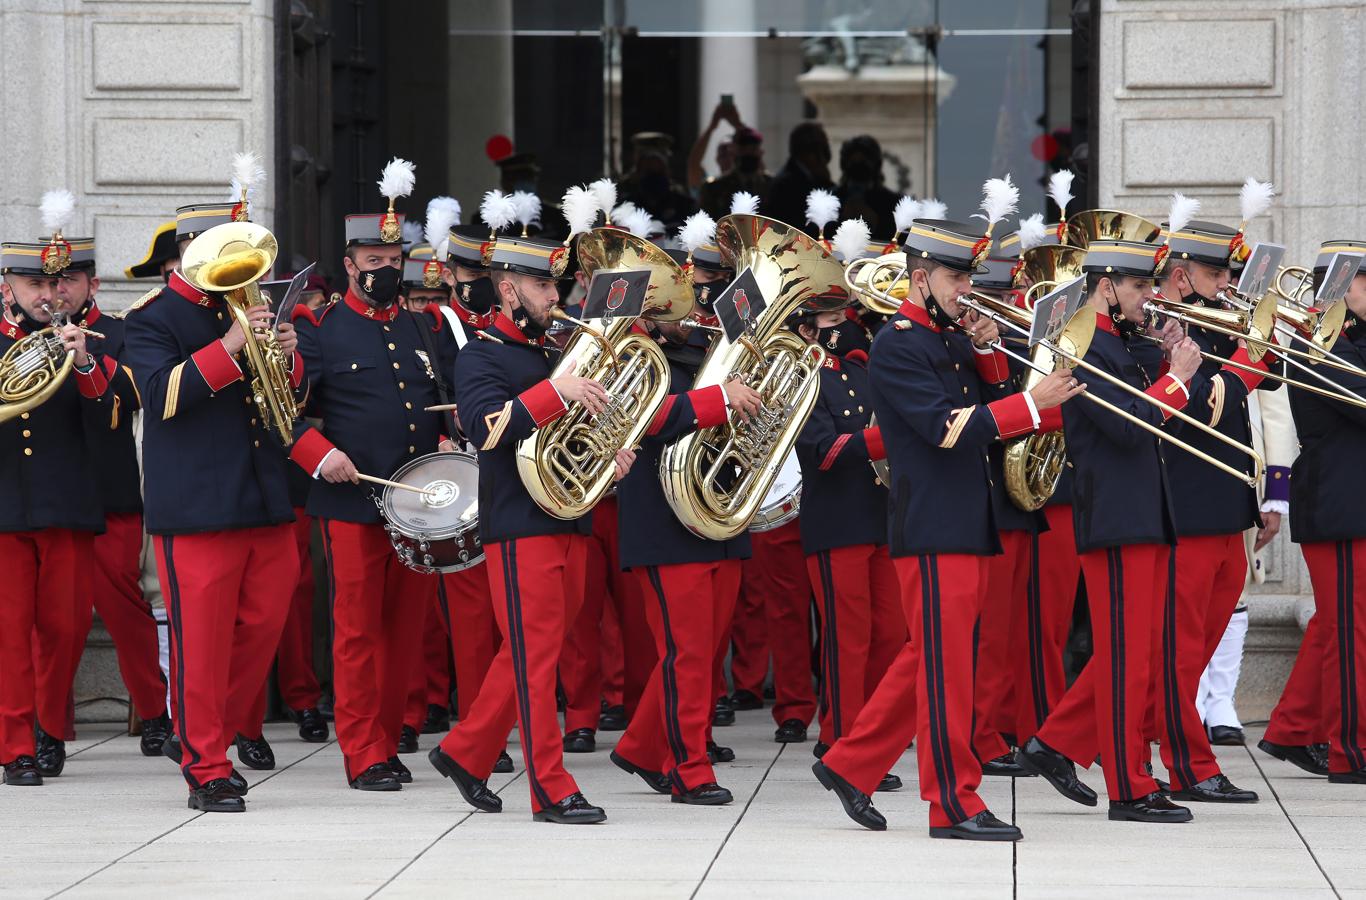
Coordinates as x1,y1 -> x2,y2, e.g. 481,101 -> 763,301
0,712 -> 1366,900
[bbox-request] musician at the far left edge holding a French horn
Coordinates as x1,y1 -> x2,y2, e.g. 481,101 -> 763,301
0,214 -> 115,787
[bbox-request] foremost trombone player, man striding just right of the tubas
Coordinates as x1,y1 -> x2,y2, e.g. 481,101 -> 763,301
813,219 -> 1079,840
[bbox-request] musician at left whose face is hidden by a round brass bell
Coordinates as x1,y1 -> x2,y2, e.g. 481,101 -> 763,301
123,193 -> 303,813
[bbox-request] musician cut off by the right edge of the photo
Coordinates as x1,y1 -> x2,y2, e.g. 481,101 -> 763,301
1259,240 -> 1366,784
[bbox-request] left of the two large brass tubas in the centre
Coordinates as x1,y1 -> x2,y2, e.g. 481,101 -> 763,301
516,228 -> 694,519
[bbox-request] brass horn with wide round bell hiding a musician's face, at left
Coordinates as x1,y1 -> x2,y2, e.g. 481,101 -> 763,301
180,221 -> 299,447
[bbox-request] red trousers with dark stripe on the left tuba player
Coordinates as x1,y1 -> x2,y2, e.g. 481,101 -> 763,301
441,534 -> 589,811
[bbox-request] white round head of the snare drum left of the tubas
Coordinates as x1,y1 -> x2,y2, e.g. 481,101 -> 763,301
382,452 -> 479,539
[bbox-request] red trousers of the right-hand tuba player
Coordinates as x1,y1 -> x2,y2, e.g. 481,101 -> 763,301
616,560 -> 740,792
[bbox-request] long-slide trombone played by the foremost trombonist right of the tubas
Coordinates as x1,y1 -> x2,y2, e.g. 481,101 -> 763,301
958,294 -> 1266,488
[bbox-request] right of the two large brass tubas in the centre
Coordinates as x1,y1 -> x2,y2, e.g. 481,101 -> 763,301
660,214 -> 844,541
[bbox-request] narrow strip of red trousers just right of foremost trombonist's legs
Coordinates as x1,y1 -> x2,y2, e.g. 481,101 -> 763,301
973,531 -> 1034,761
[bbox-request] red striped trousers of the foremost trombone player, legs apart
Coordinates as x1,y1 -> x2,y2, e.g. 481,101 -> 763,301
822,553 -> 990,828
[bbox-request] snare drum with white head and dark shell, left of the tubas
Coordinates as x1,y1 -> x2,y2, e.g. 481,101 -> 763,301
380,452 -> 484,575
